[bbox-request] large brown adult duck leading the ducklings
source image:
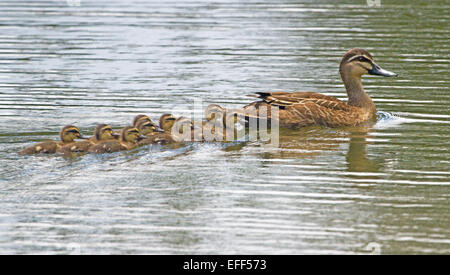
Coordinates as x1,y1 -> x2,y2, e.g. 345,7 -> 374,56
237,48 -> 397,128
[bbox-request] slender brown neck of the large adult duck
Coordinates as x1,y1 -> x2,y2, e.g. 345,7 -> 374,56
341,73 -> 376,113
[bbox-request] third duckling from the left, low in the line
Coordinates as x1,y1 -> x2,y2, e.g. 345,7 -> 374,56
88,126 -> 145,154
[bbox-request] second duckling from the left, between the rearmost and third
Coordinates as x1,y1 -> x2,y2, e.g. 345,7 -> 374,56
59,124 -> 120,154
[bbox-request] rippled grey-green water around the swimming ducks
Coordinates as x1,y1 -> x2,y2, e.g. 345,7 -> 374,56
0,0 -> 450,254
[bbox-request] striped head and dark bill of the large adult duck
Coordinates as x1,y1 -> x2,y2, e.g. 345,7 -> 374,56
339,48 -> 397,78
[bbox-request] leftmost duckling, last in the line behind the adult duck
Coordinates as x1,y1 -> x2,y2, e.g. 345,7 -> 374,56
19,125 -> 86,155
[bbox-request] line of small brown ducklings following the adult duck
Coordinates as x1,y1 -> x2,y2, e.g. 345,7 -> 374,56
19,104 -> 236,155
